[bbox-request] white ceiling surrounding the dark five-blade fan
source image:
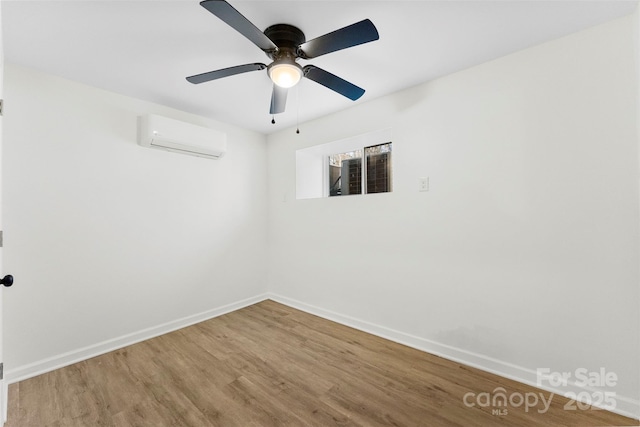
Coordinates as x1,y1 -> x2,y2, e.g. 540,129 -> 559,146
1,0 -> 638,133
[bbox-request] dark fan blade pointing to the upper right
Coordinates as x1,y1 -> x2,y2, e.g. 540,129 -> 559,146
299,19 -> 380,59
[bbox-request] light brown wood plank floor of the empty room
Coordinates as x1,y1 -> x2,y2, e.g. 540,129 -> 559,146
6,301 -> 638,427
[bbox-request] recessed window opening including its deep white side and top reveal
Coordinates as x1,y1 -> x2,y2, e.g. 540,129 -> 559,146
296,129 -> 393,199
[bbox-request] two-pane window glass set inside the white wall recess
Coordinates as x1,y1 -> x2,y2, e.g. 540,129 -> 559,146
328,142 -> 392,196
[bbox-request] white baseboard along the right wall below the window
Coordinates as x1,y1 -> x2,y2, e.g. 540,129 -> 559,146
267,293 -> 640,419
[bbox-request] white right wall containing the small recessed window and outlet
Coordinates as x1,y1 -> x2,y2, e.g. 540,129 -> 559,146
268,17 -> 640,416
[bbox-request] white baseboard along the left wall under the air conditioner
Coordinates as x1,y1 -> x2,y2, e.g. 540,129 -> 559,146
5,294 -> 268,383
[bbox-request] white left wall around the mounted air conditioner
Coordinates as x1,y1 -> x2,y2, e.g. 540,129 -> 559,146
3,65 -> 267,380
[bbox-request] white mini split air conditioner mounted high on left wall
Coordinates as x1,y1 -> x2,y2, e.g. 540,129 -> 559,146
138,114 -> 227,159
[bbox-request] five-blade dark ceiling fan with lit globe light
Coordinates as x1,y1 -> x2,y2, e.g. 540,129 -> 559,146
187,0 -> 379,114
